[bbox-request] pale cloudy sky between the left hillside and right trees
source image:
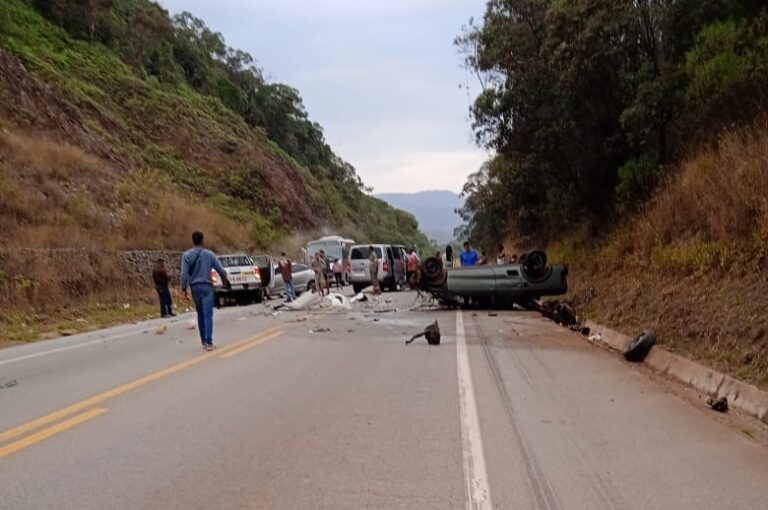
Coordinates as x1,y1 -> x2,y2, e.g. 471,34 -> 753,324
160,0 -> 487,193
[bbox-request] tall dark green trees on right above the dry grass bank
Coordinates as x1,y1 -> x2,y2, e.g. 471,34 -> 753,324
457,0 -> 768,246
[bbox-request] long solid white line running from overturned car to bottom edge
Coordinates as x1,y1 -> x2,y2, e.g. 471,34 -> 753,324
456,311 -> 493,510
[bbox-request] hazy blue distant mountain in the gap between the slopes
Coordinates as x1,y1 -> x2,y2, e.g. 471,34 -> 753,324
375,191 -> 464,244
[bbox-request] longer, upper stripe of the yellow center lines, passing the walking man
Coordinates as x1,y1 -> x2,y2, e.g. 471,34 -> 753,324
0,327 -> 278,443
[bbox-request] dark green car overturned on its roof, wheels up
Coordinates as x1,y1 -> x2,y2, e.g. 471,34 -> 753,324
413,250 -> 568,309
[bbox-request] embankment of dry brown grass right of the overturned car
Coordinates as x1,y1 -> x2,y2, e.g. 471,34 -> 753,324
550,126 -> 768,388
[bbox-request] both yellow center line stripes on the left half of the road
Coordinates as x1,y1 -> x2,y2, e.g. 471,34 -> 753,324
0,327 -> 285,458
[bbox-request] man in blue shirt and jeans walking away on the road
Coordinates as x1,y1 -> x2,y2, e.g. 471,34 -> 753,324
181,232 -> 231,351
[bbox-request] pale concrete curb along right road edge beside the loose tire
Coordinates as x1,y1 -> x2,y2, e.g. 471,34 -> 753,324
584,320 -> 768,425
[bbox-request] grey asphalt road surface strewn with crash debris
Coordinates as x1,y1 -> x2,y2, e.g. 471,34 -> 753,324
0,293 -> 768,510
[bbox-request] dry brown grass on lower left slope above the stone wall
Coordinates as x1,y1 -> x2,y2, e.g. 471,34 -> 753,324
0,131 -> 249,249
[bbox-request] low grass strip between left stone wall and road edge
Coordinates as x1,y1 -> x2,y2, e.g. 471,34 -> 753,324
0,301 -> 158,348
